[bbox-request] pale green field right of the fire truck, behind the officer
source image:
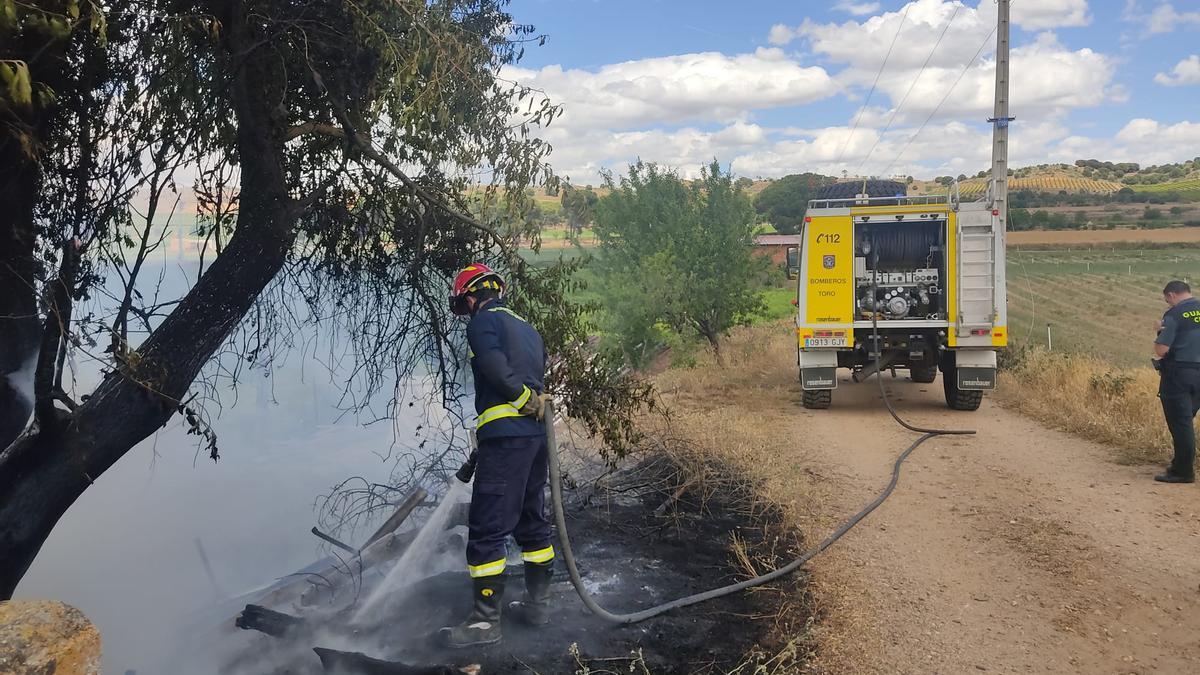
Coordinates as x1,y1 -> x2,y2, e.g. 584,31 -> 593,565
1008,249 -> 1200,366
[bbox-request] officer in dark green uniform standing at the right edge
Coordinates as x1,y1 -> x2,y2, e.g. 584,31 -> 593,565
1154,281 -> 1200,483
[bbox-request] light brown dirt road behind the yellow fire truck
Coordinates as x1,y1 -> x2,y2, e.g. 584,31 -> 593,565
790,377 -> 1200,674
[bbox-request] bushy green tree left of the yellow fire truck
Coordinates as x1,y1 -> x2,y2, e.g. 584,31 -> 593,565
595,160 -> 768,363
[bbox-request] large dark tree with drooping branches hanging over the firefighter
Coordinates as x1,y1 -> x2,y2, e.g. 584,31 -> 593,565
0,0 -> 649,598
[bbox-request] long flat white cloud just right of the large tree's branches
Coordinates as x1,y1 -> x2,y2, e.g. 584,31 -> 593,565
505,48 -> 839,130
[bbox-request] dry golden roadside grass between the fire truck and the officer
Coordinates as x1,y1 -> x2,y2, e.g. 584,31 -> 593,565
1000,350 -> 1171,464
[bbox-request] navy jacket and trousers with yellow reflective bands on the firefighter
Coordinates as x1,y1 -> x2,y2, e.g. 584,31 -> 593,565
467,300 -> 554,578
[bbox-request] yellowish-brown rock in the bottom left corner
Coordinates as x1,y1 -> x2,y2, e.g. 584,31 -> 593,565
0,601 -> 100,675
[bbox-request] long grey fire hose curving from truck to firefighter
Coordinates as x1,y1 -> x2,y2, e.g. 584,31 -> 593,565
545,266 -> 976,623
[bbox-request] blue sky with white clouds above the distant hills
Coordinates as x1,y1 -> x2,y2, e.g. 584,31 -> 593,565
510,0 -> 1200,183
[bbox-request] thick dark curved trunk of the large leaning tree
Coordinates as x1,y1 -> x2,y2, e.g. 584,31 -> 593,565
0,16 -> 299,599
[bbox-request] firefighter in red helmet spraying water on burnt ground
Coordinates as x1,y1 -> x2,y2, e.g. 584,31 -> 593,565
440,263 -> 554,647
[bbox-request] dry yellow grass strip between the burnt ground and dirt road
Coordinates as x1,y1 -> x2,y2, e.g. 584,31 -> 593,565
655,322 -> 829,675
